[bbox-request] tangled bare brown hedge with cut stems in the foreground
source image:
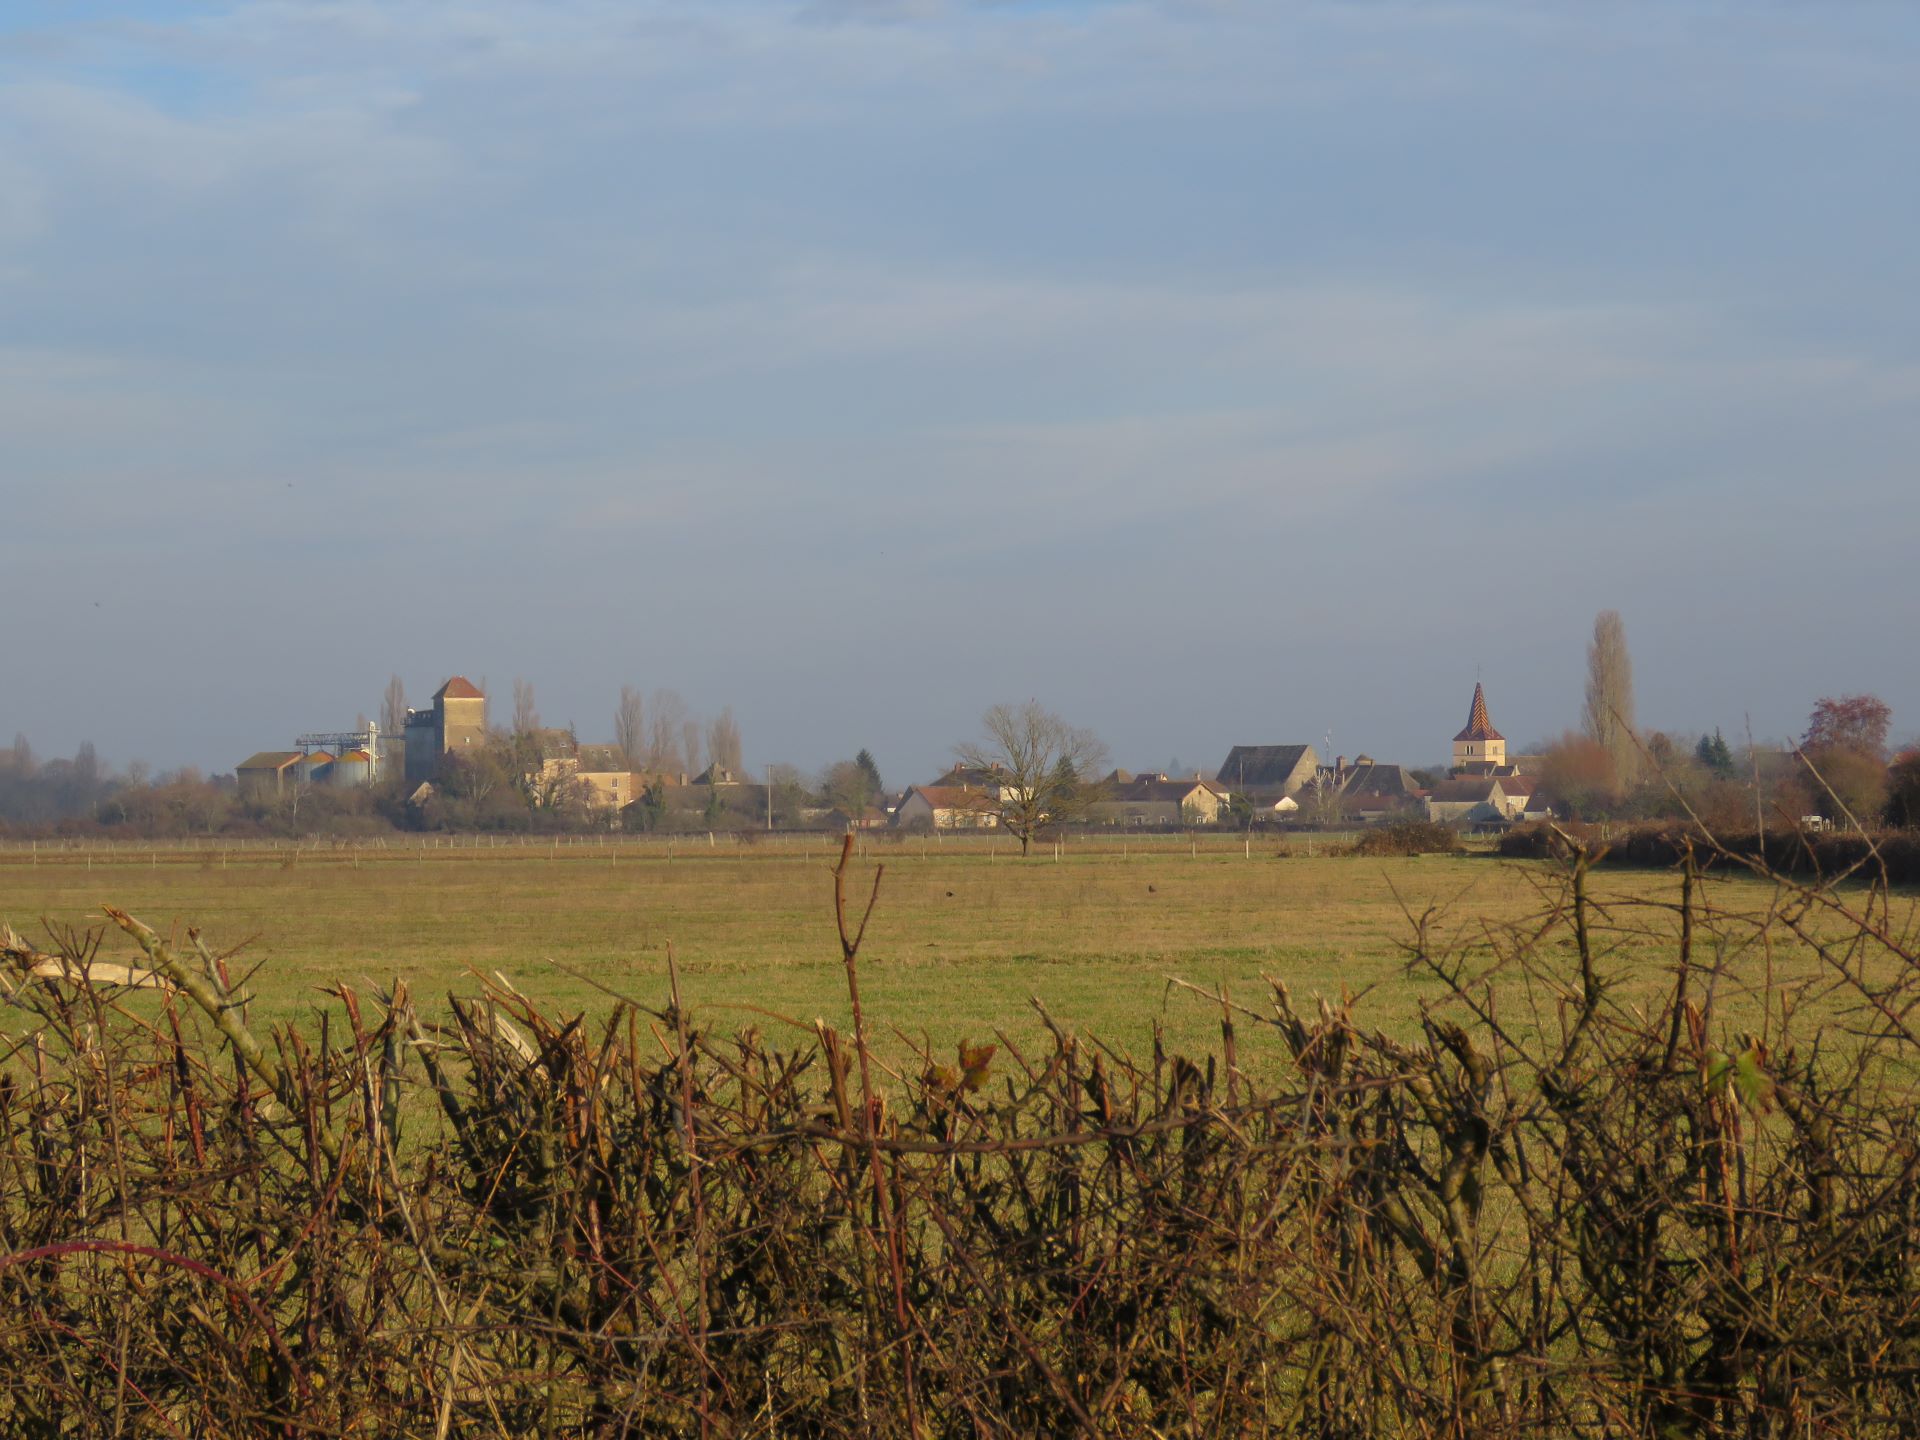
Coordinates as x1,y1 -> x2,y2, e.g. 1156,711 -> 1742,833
0,839 -> 1920,1440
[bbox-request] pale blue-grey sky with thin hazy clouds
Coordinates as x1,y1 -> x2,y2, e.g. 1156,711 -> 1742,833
0,0 -> 1920,783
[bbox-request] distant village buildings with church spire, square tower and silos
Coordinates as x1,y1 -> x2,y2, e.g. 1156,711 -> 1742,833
234,676 -> 1553,833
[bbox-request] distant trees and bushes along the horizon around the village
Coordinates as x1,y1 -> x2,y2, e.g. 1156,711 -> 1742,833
0,633 -> 1920,843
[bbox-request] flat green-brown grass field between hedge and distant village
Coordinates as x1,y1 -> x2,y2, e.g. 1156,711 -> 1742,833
0,837 -> 1889,1062
